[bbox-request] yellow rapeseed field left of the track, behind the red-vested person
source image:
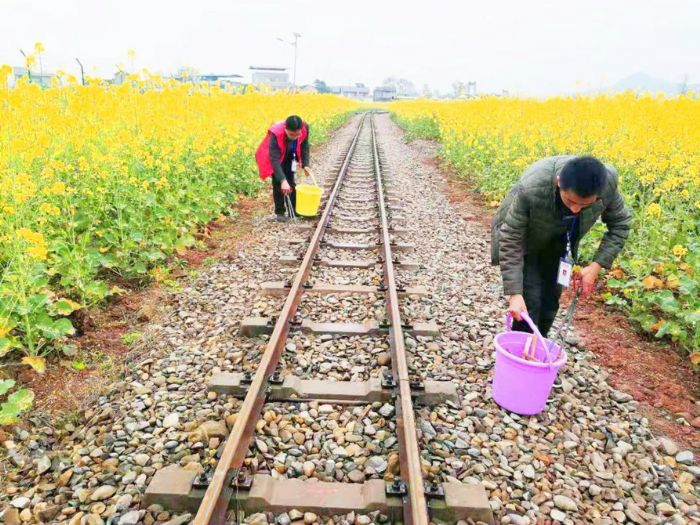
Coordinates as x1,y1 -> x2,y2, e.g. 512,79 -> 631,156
0,68 -> 356,370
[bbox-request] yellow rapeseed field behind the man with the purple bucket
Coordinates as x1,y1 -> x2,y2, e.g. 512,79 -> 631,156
389,93 -> 700,356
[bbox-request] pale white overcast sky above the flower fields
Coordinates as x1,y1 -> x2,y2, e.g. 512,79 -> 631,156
0,0 -> 700,95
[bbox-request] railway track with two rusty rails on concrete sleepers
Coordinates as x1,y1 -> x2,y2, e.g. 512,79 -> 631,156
144,113 -> 493,525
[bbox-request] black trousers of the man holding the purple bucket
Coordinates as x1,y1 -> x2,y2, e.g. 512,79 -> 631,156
513,250 -> 563,337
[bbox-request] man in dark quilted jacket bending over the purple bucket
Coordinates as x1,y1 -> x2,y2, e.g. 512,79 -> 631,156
491,156 -> 632,336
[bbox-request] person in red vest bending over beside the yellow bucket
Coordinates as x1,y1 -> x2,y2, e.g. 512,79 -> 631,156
255,115 -> 310,222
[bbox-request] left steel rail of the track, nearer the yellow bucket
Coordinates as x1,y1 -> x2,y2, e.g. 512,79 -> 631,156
192,114 -> 366,525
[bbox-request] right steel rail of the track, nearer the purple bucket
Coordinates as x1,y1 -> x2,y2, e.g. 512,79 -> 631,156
370,113 -> 430,525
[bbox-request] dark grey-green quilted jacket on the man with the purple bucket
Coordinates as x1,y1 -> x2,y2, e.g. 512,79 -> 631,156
491,156 -> 632,295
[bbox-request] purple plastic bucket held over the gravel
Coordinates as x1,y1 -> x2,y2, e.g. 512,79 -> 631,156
493,314 -> 567,416
